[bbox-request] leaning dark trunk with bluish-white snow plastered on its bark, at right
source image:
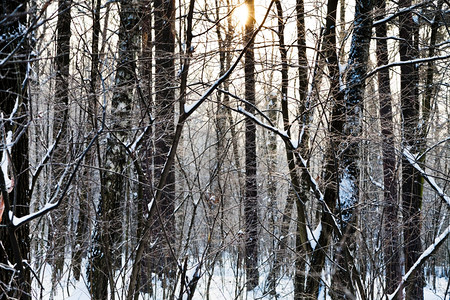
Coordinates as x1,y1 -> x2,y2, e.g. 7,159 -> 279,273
332,0 -> 373,299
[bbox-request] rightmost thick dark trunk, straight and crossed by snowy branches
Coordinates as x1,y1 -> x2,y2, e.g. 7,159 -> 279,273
399,0 -> 424,300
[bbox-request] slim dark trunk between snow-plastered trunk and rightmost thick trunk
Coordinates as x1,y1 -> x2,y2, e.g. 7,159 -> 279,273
376,0 -> 402,300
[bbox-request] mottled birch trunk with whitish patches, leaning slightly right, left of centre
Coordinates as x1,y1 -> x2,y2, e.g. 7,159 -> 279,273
90,0 -> 138,299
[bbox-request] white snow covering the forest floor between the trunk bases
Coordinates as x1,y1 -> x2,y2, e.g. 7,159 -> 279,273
32,244 -> 447,300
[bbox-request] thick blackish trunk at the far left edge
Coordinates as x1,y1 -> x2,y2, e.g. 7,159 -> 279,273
0,0 -> 31,299
